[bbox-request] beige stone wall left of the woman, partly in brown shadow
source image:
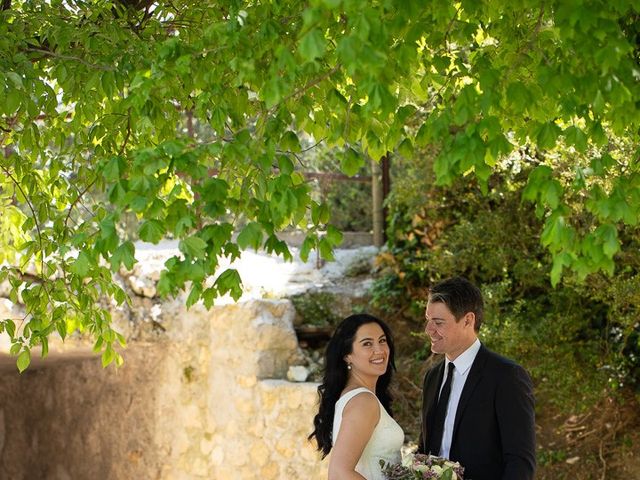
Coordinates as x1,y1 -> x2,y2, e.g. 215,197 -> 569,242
0,300 -> 327,480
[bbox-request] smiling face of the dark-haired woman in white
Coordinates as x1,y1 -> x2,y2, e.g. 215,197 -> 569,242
345,322 -> 389,377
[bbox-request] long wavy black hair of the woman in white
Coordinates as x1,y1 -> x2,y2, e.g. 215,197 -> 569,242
309,313 -> 396,458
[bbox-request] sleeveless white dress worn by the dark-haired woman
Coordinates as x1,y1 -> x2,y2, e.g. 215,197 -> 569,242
333,387 -> 404,480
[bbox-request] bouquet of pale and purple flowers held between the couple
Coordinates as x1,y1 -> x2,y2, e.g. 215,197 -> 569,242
380,453 -> 464,480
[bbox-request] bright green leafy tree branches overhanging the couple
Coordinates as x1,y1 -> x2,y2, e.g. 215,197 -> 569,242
0,0 -> 640,370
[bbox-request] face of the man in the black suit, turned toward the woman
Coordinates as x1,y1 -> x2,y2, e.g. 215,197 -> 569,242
425,302 -> 476,360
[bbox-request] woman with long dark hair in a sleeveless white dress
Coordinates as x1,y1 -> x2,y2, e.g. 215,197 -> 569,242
309,314 -> 404,480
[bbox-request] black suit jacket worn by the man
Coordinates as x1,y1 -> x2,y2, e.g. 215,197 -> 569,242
418,346 -> 536,480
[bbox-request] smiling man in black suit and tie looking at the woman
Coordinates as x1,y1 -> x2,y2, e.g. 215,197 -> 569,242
418,277 -> 536,480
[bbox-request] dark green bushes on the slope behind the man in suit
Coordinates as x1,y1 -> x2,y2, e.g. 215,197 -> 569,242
373,143 -> 640,438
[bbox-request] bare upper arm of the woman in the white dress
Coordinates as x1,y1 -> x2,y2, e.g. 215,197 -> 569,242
329,394 -> 380,480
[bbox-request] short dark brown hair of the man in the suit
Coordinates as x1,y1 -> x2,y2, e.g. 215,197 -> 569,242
429,277 -> 484,332
